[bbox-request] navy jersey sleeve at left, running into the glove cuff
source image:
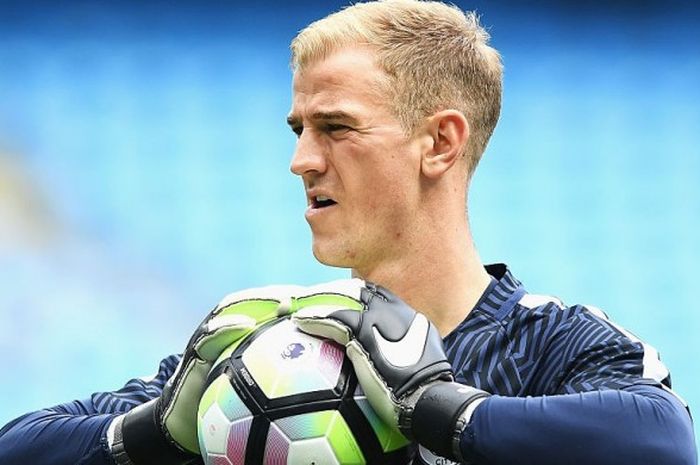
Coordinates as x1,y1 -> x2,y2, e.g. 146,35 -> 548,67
0,355 -> 180,465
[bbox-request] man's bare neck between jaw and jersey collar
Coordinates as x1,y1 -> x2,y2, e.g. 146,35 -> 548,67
353,218 -> 490,337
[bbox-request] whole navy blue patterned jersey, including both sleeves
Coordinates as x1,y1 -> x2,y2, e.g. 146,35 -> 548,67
0,265 -> 697,465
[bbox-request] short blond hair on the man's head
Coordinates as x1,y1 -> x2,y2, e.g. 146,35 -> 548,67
291,0 -> 503,176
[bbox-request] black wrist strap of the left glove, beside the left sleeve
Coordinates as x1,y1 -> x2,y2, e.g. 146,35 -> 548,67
119,399 -> 196,465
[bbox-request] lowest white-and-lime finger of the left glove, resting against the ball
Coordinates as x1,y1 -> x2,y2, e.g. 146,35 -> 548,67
194,315 -> 257,363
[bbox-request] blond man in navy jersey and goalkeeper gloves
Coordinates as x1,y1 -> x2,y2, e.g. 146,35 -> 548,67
0,0 -> 696,465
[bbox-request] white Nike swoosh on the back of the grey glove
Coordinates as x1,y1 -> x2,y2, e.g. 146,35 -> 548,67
372,313 -> 430,368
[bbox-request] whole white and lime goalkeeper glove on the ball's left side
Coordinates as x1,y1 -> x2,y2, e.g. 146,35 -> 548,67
110,286 -> 313,465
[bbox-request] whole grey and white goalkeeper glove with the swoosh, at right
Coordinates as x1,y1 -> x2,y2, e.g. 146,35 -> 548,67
292,279 -> 489,460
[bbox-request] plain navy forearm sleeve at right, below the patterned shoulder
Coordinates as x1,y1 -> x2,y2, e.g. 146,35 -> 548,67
460,384 -> 697,465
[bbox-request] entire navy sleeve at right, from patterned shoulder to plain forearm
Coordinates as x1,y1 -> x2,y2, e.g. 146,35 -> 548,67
460,307 -> 697,465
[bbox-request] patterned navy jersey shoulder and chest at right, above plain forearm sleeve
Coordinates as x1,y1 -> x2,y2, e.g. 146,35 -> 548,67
444,265 -> 671,397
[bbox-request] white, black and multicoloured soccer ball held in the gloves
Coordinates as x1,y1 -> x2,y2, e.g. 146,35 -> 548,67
197,318 -> 412,465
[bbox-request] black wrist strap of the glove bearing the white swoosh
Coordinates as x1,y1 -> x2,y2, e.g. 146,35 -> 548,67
411,382 -> 490,460
